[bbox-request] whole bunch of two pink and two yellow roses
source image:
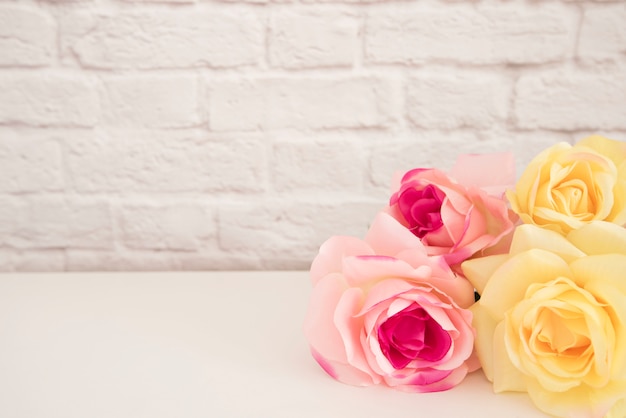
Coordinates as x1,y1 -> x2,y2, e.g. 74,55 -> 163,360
305,136 -> 626,418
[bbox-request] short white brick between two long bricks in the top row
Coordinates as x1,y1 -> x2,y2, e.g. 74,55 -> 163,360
269,11 -> 358,69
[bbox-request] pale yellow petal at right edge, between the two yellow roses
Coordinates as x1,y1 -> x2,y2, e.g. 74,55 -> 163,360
567,221 -> 626,255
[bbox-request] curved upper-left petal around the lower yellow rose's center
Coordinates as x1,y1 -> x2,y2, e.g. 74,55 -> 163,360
480,249 -> 571,321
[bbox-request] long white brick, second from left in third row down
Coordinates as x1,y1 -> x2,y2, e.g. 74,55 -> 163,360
67,131 -> 267,193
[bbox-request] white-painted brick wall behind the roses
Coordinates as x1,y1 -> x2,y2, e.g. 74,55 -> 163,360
0,0 -> 626,271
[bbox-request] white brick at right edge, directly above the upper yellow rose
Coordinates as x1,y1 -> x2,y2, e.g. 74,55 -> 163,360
515,72 -> 626,131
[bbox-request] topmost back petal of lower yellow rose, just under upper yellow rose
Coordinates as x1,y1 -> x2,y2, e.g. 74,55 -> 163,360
510,225 -> 585,263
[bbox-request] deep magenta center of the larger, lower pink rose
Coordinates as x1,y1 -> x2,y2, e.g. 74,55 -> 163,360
378,303 -> 452,369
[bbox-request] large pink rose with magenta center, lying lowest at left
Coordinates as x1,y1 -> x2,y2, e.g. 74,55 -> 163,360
304,213 -> 477,392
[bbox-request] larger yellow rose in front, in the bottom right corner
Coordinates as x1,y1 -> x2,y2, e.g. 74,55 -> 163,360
462,221 -> 626,418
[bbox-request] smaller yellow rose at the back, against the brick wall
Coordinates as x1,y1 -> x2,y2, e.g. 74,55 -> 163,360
507,135 -> 626,234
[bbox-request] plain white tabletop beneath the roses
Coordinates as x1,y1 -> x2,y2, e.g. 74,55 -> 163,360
0,272 -> 545,418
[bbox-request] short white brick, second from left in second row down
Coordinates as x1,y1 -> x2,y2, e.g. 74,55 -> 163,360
103,75 -> 201,128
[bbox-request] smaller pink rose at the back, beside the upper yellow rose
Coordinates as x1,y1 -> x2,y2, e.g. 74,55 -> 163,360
388,154 -> 515,266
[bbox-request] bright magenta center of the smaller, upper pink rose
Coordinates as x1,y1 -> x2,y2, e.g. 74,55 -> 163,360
398,184 -> 446,238
